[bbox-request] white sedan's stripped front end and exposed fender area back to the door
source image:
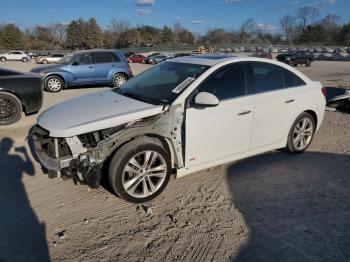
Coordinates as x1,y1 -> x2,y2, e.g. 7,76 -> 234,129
31,110 -> 183,188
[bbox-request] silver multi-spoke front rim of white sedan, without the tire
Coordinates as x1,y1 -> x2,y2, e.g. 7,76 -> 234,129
122,151 -> 167,198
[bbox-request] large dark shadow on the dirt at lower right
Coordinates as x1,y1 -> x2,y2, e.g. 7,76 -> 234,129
227,152 -> 350,262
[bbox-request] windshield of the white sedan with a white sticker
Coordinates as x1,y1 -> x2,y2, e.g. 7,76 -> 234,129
115,61 -> 209,105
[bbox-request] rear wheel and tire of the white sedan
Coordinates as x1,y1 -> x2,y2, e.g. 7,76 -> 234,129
286,112 -> 316,153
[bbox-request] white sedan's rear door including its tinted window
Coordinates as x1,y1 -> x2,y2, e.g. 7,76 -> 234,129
249,62 -> 294,150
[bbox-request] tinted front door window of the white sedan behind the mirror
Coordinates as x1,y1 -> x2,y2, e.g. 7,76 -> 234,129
198,64 -> 246,100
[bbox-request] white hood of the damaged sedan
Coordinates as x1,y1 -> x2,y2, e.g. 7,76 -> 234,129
38,91 -> 163,137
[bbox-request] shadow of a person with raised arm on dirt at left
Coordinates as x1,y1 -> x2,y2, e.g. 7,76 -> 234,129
0,137 -> 50,261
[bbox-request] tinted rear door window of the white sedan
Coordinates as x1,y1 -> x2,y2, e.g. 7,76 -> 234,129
253,62 -> 284,94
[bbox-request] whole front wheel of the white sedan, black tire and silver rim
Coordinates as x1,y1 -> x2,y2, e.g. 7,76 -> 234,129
108,137 -> 171,203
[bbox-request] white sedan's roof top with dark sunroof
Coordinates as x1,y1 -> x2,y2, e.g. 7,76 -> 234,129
168,54 -> 238,66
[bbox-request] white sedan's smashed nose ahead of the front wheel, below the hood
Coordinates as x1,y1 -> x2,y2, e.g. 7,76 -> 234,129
32,126 -> 115,188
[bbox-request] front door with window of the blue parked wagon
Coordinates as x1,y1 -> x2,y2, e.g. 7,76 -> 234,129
68,53 -> 94,85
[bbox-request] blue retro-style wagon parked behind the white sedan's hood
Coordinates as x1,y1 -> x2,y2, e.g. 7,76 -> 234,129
32,50 -> 132,92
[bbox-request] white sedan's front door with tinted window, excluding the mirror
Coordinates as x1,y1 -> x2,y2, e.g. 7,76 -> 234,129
185,63 -> 253,167
